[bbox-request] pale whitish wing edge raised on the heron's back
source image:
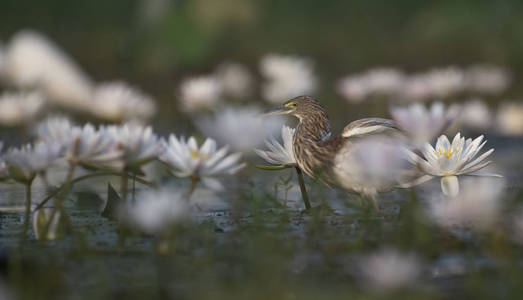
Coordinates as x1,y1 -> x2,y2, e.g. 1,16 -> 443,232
341,118 -> 400,138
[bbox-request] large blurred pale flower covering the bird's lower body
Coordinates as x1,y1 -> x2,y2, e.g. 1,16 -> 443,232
334,138 -> 408,196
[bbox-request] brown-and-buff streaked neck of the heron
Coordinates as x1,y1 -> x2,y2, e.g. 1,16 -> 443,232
293,112 -> 331,177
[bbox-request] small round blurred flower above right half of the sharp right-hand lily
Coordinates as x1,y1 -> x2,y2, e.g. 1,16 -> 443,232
458,99 -> 493,129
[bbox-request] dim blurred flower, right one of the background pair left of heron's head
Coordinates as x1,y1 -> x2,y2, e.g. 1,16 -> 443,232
216,63 -> 253,99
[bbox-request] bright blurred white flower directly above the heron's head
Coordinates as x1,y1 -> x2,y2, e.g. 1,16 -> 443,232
260,55 -> 318,103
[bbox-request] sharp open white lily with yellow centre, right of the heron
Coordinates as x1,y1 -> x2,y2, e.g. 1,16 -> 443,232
410,133 -> 500,196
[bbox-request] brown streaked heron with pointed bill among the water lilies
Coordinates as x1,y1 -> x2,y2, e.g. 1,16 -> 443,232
265,96 -> 418,210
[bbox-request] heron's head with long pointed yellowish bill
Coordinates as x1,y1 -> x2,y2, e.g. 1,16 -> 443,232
265,96 -> 325,120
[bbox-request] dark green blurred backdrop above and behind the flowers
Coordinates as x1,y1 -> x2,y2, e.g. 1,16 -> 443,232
0,0 -> 523,131
